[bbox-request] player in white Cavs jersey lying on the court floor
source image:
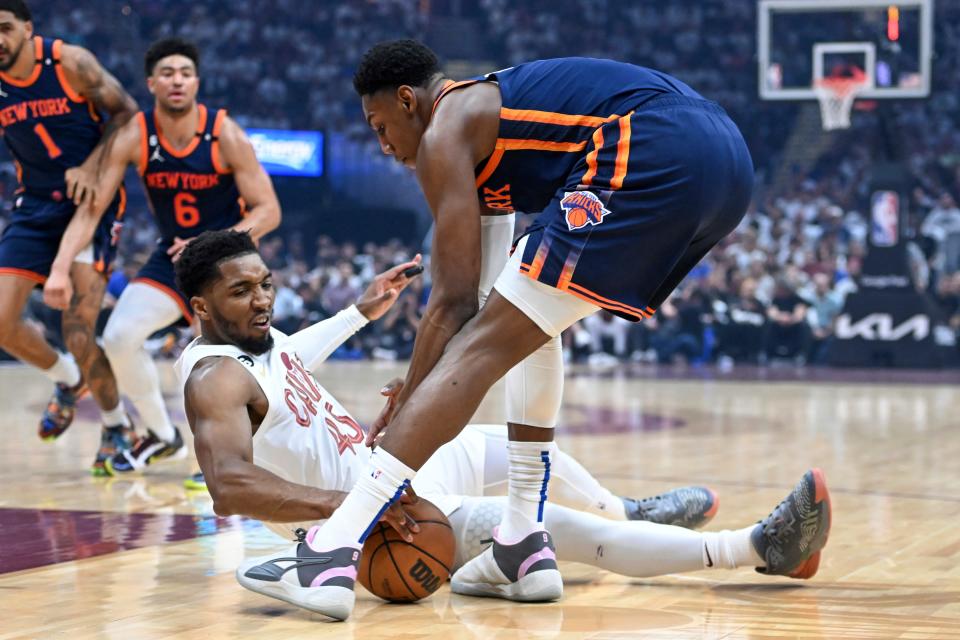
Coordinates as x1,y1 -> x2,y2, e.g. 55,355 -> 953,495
177,231 -> 830,619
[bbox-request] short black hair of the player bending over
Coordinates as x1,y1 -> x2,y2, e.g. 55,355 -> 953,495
353,40 -> 440,96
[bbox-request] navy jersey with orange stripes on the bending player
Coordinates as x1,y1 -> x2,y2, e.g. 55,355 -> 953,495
437,58 -> 700,213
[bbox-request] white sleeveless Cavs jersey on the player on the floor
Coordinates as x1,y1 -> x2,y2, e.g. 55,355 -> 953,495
177,329 -> 370,500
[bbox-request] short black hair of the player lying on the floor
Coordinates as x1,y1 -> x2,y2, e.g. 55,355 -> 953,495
175,229 -> 257,298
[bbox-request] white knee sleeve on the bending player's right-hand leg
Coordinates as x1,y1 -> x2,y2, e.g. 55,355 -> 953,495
506,336 -> 563,429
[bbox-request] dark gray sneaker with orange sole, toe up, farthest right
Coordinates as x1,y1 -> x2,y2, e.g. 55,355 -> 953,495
750,469 -> 832,580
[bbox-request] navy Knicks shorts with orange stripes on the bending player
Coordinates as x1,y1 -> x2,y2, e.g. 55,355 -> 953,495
520,95 -> 753,321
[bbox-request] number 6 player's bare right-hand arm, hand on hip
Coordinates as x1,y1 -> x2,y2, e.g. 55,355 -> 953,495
219,117 -> 281,241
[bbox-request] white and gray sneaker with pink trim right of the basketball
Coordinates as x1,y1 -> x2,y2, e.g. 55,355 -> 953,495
450,531 -> 563,602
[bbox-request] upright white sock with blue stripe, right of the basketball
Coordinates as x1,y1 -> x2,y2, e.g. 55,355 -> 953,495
497,441 -> 556,544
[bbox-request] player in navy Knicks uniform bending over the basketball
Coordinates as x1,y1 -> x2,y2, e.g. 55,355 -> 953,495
288,40 -> 825,616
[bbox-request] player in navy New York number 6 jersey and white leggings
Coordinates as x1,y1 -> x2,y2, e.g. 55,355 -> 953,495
44,38 -> 280,473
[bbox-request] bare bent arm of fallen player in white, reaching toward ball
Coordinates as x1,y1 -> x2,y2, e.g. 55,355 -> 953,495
184,357 -> 346,522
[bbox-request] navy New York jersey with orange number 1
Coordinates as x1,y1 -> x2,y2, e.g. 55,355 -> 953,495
0,36 -> 103,201
